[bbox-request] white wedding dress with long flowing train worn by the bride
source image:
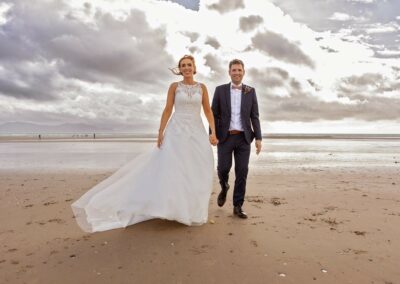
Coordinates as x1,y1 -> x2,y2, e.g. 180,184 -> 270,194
72,83 -> 214,232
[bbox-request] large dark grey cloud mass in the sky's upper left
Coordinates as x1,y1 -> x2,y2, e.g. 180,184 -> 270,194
0,2 -> 173,100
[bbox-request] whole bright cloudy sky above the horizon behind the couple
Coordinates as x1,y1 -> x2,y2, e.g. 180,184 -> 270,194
0,0 -> 400,134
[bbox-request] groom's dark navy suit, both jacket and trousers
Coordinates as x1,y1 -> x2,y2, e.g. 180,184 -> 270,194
211,83 -> 262,206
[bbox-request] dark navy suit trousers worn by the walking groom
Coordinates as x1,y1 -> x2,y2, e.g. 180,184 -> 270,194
217,133 -> 251,206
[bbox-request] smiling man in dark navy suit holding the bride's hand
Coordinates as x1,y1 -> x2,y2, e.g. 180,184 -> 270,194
211,59 -> 262,219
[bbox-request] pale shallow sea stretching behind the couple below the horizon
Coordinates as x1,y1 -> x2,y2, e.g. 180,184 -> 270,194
0,133 -> 400,173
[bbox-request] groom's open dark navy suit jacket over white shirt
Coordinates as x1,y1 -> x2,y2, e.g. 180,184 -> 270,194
211,83 -> 262,144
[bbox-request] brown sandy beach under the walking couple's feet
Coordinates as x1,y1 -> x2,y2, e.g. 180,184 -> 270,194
0,139 -> 400,284
